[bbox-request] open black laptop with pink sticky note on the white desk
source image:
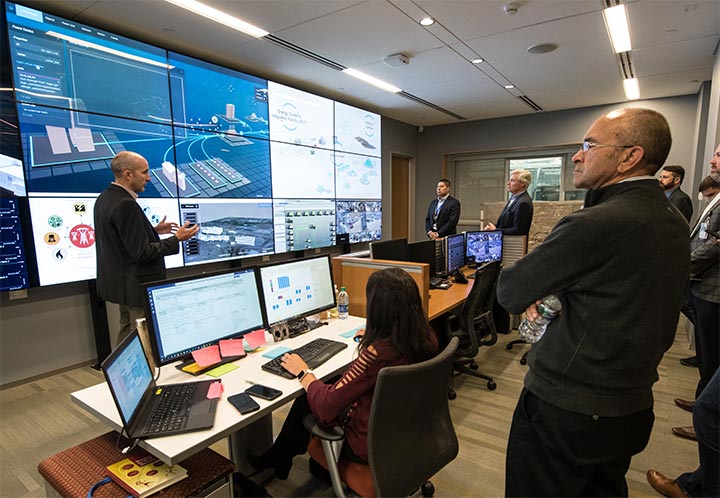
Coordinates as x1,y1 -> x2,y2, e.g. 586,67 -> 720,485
102,331 -> 219,439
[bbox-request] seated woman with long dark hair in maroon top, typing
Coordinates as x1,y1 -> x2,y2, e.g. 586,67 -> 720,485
248,268 -> 438,479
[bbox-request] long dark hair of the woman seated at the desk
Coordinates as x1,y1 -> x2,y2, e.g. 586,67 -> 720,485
360,268 -> 435,363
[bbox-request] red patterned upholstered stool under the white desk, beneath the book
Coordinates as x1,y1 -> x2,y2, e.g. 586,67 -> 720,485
38,432 -> 235,498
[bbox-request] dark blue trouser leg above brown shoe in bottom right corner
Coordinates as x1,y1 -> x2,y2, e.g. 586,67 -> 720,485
677,370 -> 720,496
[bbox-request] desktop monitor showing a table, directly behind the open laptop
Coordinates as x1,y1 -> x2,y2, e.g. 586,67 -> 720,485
144,268 -> 265,366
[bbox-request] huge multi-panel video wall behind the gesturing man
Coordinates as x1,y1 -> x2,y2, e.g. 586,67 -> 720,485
0,2 -> 382,290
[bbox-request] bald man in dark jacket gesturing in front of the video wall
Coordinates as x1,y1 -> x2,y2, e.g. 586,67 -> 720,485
94,151 -> 200,341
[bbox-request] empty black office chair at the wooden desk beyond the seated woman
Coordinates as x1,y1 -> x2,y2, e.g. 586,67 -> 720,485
447,261 -> 500,399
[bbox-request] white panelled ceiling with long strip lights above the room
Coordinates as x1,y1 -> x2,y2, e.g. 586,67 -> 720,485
20,0 -> 720,126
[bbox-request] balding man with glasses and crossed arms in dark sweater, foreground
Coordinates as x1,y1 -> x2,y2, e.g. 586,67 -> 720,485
497,108 -> 690,496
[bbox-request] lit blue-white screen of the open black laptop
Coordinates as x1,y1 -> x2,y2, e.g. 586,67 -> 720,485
103,332 -> 153,427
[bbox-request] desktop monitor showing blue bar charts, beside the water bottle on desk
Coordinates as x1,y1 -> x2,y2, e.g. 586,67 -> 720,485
259,255 -> 335,326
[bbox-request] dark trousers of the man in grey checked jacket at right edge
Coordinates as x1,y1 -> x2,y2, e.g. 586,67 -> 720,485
692,296 -> 720,399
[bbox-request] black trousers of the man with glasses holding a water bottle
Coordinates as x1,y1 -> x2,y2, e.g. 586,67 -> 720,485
505,389 -> 655,496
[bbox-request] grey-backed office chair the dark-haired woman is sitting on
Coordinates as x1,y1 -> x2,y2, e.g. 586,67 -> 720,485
305,338 -> 459,498
